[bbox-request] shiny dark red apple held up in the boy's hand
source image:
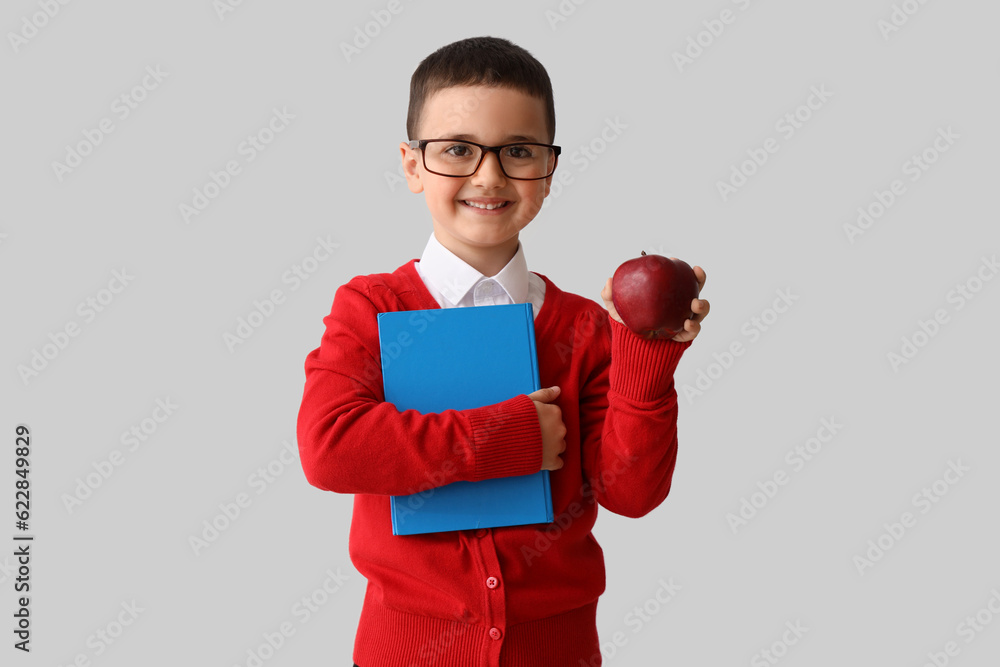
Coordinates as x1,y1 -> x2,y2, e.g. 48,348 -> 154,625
611,250 -> 699,339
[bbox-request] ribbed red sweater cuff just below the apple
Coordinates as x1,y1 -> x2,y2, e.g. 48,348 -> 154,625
608,318 -> 694,403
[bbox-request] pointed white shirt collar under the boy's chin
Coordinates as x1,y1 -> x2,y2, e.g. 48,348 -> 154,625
420,232 -> 528,306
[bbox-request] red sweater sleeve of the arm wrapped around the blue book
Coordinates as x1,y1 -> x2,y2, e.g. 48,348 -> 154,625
296,276 -> 542,495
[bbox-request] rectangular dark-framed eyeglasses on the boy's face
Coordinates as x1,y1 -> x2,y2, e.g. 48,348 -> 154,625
410,139 -> 562,181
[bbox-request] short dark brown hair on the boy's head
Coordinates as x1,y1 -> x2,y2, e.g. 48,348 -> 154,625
406,37 -> 556,143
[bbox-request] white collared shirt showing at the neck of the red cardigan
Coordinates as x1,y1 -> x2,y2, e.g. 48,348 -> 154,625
415,232 -> 545,317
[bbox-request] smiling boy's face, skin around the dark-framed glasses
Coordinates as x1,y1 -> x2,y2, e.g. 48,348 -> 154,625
400,86 -> 552,270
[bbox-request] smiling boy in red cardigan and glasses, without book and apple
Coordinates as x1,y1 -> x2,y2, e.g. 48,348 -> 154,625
297,37 -> 709,667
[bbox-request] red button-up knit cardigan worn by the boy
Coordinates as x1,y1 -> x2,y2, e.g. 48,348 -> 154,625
297,259 -> 691,667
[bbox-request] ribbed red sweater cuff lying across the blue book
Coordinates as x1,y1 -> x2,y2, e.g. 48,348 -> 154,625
465,394 -> 542,481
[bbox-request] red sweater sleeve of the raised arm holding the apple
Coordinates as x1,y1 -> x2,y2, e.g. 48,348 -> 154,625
580,311 -> 691,518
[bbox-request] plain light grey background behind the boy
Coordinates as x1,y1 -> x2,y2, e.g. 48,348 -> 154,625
0,0 -> 1000,666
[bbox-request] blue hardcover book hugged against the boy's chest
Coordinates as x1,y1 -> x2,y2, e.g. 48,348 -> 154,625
378,303 -> 553,535
